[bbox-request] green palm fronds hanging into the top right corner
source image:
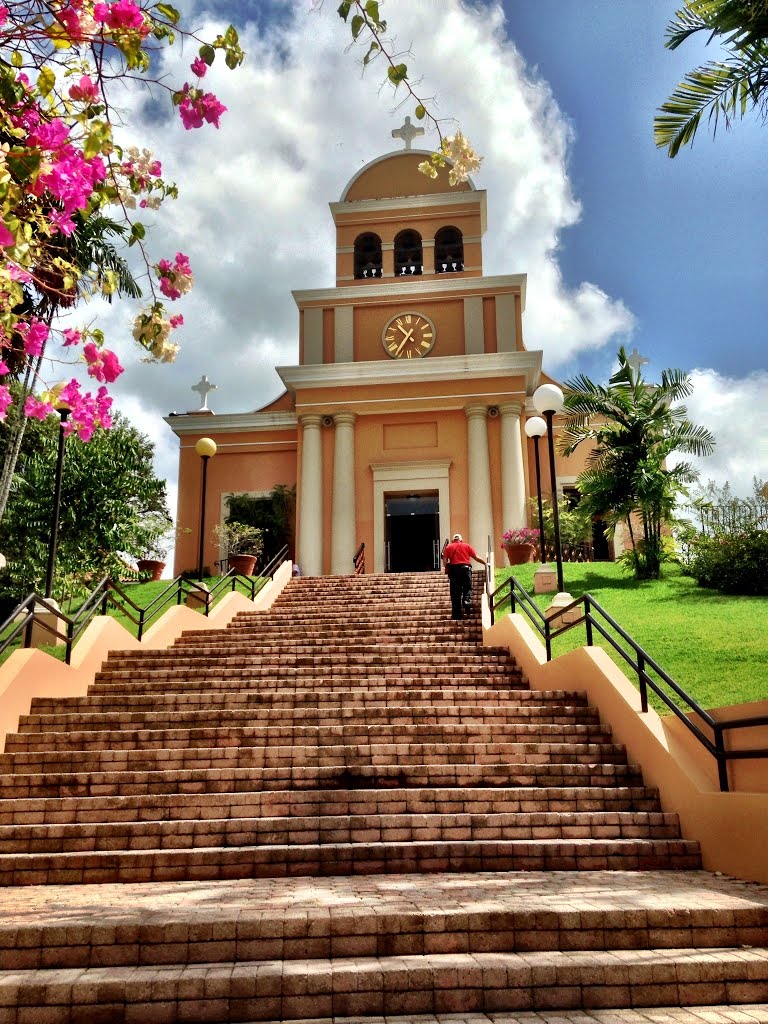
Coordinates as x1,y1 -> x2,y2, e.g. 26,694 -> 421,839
653,0 -> 768,157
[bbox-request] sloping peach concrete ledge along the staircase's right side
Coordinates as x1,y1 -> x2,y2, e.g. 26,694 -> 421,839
483,608 -> 768,882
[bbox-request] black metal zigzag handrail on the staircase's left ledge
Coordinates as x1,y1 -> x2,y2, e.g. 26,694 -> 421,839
0,545 -> 288,665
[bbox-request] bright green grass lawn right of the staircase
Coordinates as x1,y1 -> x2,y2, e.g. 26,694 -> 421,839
497,562 -> 768,710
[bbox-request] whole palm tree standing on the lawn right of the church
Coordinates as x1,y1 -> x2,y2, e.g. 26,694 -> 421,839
561,348 -> 715,579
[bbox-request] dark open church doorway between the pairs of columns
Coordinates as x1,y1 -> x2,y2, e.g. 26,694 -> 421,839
384,492 -> 440,572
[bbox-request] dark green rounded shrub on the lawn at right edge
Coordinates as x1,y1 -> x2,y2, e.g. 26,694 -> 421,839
685,529 -> 768,594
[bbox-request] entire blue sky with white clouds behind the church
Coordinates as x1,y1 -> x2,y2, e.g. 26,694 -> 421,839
100,0 -> 768,512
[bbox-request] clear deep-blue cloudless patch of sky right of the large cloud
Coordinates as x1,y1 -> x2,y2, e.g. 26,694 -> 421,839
504,0 -> 768,385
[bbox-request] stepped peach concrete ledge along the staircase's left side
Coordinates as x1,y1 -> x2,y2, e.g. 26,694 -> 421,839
0,561 -> 293,750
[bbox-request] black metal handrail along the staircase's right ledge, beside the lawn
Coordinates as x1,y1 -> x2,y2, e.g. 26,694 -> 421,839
488,577 -> 768,793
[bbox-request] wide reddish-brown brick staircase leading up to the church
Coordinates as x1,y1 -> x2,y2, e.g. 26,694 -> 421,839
0,573 -> 768,1024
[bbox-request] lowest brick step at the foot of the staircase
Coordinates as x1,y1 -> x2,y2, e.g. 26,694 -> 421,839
0,947 -> 768,1024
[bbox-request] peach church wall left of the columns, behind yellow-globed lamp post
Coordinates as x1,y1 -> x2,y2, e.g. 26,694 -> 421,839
174,430 -> 297,575
